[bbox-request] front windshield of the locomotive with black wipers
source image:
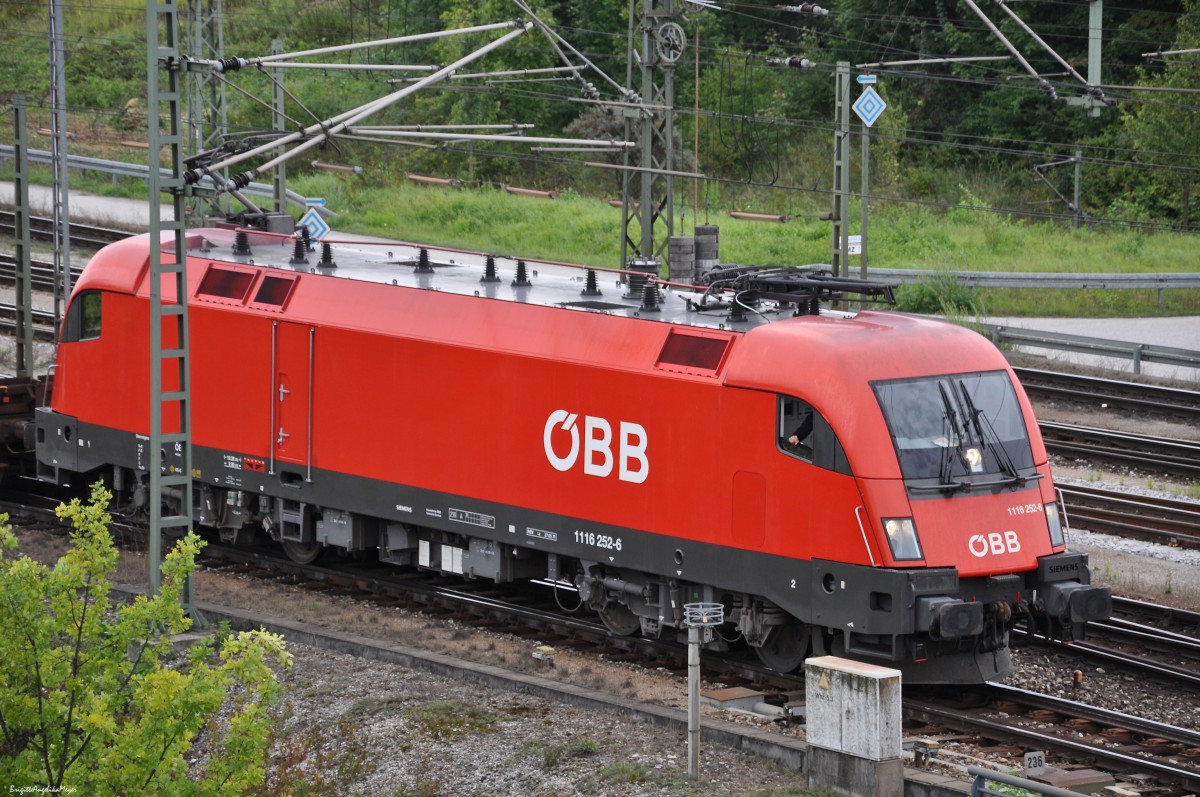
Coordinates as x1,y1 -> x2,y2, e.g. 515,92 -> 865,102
872,371 -> 1033,486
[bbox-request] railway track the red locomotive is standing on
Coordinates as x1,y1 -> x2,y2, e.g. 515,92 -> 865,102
14,494 -> 1200,795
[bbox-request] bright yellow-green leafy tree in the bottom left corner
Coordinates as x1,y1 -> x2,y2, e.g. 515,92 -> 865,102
0,484 -> 290,796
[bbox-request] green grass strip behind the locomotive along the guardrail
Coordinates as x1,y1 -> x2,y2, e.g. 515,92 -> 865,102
309,175 -> 1200,317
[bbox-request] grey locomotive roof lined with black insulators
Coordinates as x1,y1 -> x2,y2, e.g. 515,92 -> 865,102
133,228 -> 902,331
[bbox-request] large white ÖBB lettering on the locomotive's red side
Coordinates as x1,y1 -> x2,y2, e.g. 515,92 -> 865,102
541,409 -> 650,484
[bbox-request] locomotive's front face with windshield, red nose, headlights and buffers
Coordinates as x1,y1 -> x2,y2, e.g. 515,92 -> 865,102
847,370 -> 1111,682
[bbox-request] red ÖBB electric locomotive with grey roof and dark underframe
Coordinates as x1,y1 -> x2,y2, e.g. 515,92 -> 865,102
37,229 -> 1110,683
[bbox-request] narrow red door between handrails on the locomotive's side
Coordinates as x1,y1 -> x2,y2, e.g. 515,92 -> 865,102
271,322 -> 317,472
